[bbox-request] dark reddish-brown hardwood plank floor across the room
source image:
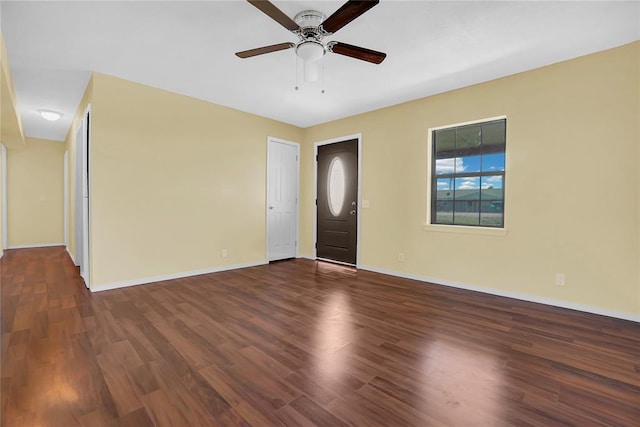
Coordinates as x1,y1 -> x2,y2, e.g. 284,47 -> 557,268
1,248 -> 640,427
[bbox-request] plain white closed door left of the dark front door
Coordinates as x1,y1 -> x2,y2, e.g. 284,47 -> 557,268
267,138 -> 300,261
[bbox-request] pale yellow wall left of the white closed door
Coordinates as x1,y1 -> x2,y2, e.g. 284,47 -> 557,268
90,73 -> 302,288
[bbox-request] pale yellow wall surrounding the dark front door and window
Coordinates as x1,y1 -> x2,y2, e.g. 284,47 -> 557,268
301,43 -> 640,318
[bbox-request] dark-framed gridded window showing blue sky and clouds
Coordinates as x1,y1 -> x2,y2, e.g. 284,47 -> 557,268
430,119 -> 506,228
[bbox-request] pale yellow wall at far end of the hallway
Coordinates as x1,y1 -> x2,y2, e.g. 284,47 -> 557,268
7,138 -> 65,248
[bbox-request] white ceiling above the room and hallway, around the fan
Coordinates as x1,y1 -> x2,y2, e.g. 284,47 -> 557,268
0,0 -> 640,140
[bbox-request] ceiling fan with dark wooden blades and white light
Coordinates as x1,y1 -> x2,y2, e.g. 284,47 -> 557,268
236,0 -> 387,81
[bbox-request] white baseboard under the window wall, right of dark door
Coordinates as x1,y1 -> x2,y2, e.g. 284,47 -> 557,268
358,265 -> 640,322
